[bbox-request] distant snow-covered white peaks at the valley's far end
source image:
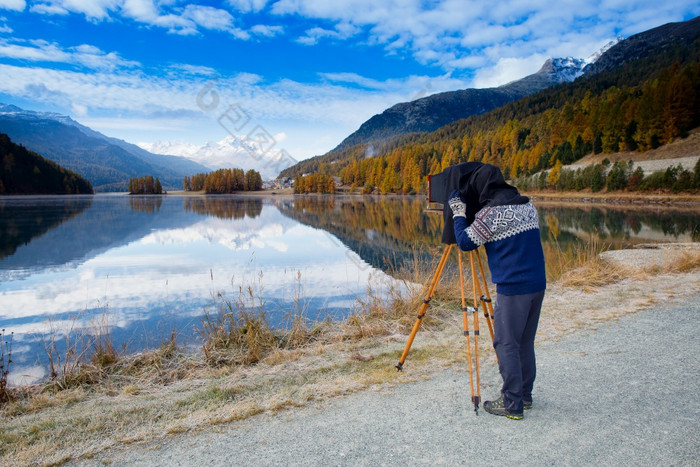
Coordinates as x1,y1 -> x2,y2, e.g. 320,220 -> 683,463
139,135 -> 279,179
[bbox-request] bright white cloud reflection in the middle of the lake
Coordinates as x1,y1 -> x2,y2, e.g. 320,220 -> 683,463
0,208 -> 402,348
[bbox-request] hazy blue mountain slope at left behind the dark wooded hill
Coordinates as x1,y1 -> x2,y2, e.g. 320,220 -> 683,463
0,104 -> 209,191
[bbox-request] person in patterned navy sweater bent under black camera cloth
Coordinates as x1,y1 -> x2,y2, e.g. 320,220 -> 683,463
449,162 -> 546,420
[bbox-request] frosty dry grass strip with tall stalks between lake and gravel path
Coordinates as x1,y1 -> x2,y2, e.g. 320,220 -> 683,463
0,248 -> 700,465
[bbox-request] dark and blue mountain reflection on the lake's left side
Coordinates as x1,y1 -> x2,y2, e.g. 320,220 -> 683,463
0,195 -> 270,276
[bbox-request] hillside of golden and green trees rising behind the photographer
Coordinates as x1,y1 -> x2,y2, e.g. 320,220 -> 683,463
284,18 -> 700,193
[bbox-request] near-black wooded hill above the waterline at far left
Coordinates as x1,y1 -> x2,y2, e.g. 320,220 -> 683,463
0,133 -> 93,195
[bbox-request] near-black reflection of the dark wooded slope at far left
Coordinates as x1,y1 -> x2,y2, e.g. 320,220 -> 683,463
0,197 -> 93,259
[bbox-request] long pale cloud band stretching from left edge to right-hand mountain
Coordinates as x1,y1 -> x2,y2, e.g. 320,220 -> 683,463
0,60 -> 404,139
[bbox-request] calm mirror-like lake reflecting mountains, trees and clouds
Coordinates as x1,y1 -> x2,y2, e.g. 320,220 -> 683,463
0,195 -> 700,384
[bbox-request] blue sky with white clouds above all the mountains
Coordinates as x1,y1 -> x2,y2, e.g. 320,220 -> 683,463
0,0 -> 700,168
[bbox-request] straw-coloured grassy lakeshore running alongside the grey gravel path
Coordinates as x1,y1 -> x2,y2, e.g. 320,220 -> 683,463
0,244 -> 700,464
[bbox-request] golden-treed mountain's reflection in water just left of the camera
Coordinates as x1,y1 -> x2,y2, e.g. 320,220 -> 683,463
277,197 -> 442,271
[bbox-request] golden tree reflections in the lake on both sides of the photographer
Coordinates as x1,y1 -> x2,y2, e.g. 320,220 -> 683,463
276,196 -> 700,270
